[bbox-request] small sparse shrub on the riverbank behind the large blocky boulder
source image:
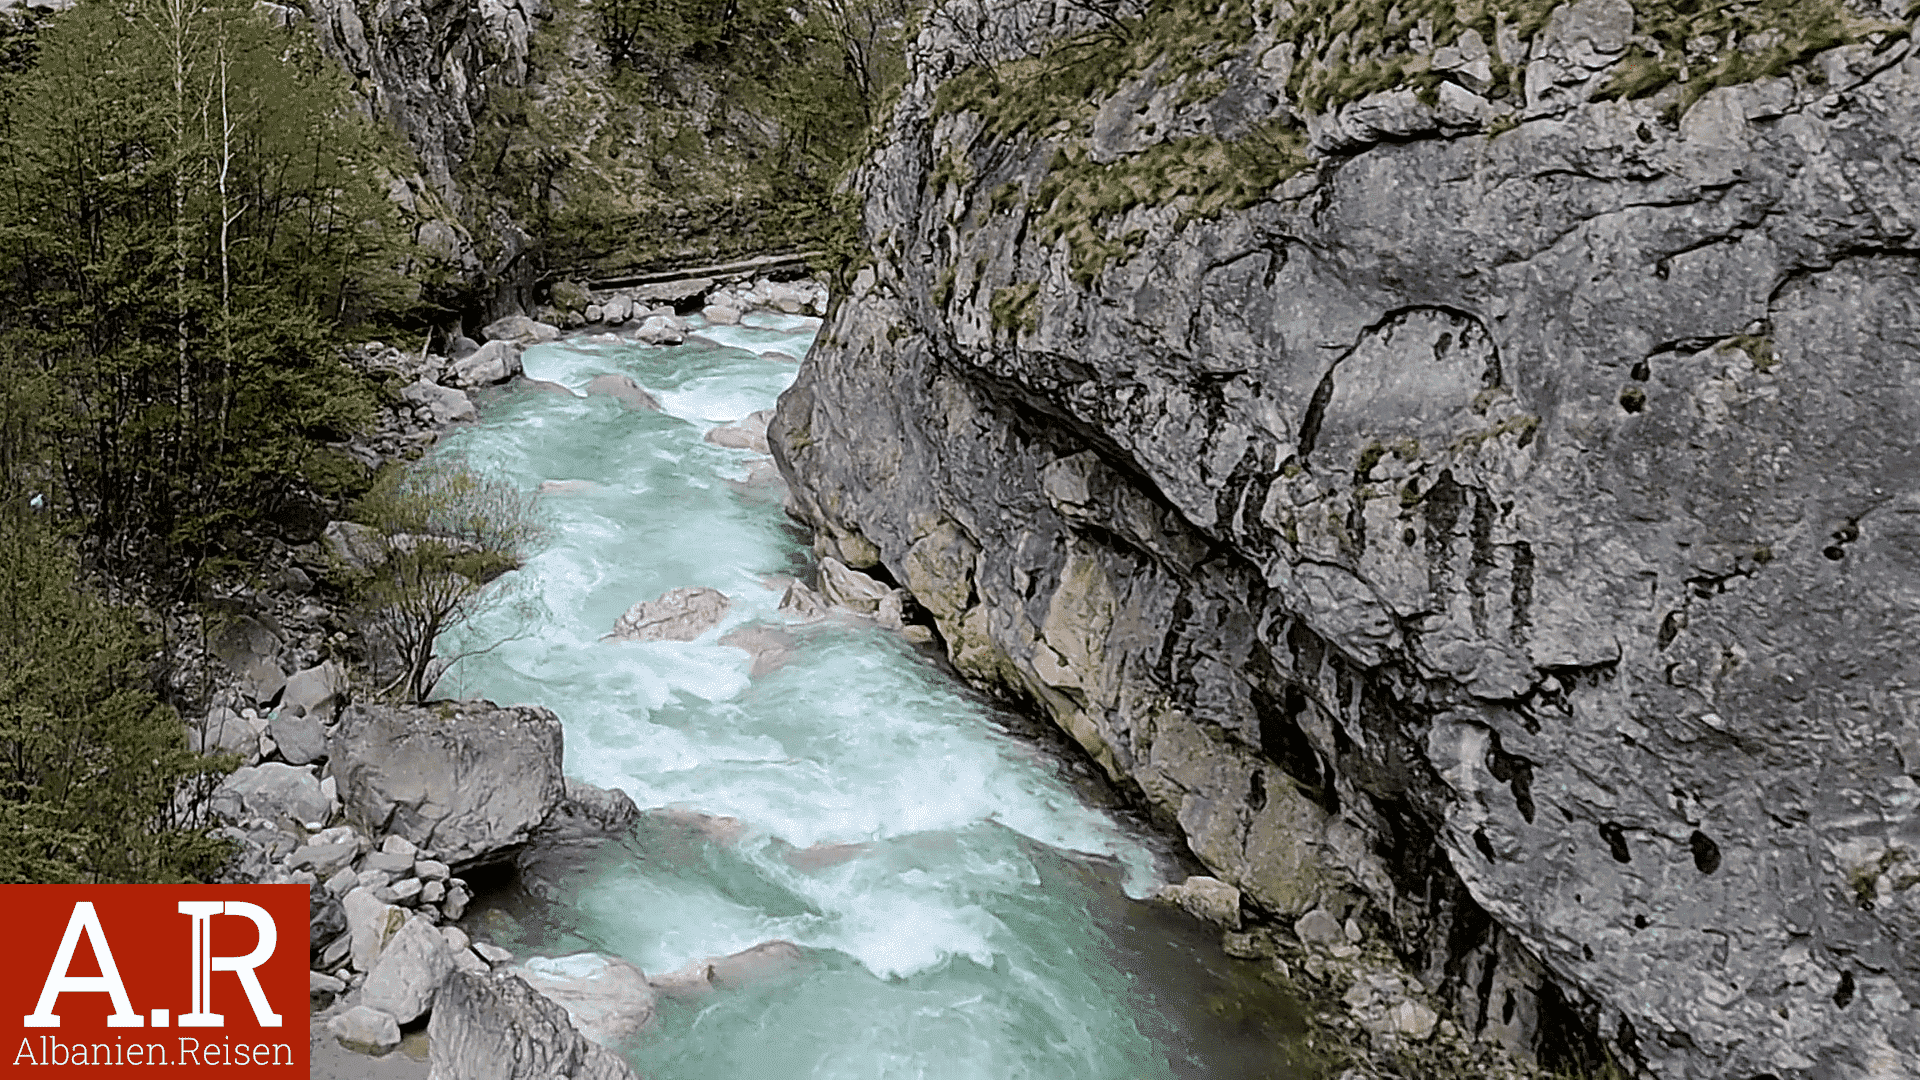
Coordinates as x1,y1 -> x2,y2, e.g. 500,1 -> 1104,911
340,457 -> 547,701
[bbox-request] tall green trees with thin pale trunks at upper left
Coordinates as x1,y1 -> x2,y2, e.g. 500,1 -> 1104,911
0,0 -> 411,569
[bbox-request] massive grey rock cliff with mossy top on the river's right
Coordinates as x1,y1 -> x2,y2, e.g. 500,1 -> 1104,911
772,0 -> 1920,1080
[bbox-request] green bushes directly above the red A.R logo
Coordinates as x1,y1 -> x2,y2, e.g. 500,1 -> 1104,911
0,502 -> 234,882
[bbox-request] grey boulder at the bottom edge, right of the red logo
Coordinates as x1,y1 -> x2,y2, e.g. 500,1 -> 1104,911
426,970 -> 639,1080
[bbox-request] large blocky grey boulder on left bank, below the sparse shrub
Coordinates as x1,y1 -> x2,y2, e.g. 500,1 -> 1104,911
326,701 -> 564,871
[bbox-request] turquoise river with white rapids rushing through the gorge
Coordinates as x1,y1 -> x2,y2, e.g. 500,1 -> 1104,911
424,313 -> 1319,1080
